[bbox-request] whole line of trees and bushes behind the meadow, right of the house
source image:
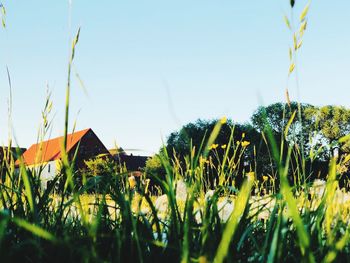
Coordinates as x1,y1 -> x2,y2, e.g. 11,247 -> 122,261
146,102 -> 350,191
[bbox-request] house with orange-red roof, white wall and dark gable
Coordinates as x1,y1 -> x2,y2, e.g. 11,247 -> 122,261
16,128 -> 109,187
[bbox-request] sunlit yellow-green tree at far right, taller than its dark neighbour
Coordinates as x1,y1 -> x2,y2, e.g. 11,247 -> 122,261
251,102 -> 350,184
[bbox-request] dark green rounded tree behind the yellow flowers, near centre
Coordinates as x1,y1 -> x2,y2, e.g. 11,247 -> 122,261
166,119 -> 265,189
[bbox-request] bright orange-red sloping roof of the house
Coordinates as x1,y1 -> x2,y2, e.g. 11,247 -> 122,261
16,128 -> 91,165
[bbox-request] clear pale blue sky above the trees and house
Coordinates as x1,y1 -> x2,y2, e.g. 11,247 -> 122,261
0,0 -> 350,155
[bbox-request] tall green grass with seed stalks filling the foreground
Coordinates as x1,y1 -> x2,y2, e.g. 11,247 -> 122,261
0,1 -> 350,263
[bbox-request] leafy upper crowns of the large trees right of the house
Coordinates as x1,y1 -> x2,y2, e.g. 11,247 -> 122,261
152,102 -> 350,185
